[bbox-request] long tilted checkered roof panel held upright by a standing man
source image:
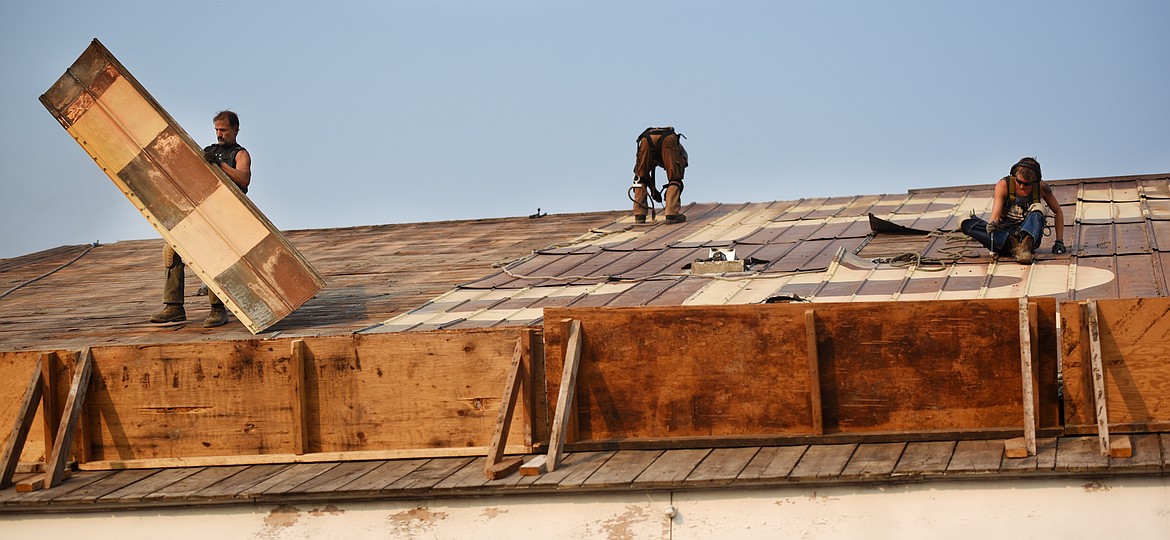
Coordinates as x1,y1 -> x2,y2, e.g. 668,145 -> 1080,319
41,40 -> 324,333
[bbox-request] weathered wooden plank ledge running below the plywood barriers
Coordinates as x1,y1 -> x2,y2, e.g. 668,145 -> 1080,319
0,434 -> 1170,513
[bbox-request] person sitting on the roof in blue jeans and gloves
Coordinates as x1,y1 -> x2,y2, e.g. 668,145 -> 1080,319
959,158 -> 1067,264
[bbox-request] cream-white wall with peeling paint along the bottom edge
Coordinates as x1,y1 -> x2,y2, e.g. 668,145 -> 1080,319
0,477 -> 1170,540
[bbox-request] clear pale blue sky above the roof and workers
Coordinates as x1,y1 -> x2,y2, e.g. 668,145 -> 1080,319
0,0 -> 1170,258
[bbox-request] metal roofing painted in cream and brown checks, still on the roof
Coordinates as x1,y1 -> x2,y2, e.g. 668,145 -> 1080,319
369,174 -> 1170,332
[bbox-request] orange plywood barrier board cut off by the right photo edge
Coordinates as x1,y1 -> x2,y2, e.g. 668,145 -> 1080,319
1060,298 -> 1170,434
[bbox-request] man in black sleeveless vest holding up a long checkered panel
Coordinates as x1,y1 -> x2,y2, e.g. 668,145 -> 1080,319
150,111 -> 252,328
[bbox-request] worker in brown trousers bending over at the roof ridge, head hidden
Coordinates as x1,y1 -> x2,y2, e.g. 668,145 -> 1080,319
629,126 -> 687,223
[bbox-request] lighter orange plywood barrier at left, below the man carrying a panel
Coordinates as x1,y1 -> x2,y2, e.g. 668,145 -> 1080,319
0,328 -> 539,468
